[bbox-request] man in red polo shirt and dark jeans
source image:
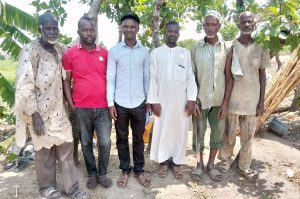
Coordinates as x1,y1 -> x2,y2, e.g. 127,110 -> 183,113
62,16 -> 112,189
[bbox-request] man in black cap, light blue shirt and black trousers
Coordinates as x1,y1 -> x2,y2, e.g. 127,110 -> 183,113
107,13 -> 150,188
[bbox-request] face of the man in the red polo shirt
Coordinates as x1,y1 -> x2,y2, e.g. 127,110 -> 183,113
77,20 -> 97,45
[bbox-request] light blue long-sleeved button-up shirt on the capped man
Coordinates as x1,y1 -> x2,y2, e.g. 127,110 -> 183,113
106,42 -> 150,108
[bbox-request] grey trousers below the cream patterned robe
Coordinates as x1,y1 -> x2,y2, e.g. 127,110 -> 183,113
35,142 -> 78,195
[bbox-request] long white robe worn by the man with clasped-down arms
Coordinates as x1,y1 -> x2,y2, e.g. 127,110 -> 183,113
147,45 -> 197,164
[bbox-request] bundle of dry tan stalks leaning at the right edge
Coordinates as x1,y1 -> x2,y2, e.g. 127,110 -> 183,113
256,47 -> 300,132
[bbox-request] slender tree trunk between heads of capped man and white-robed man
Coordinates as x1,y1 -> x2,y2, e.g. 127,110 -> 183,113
152,0 -> 165,48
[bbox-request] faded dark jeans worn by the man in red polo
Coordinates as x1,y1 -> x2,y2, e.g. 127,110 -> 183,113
75,108 -> 112,176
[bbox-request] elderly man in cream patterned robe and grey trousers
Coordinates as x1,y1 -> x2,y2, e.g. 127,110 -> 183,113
15,13 -> 86,199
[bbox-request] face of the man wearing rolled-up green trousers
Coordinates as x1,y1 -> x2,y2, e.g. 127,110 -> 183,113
203,16 -> 221,38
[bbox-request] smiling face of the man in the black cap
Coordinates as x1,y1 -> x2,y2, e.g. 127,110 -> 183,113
121,19 -> 139,40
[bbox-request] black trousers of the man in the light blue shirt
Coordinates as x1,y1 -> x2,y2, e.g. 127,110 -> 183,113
115,102 -> 146,173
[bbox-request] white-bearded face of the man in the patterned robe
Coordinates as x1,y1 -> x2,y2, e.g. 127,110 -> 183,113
40,21 -> 59,44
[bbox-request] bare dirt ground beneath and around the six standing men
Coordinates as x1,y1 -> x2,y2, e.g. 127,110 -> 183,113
0,57 -> 300,199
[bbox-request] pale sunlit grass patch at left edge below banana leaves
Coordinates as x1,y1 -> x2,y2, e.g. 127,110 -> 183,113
0,59 -> 17,83
